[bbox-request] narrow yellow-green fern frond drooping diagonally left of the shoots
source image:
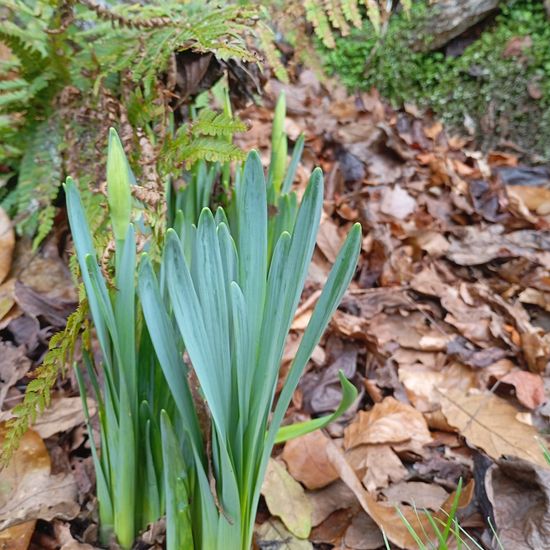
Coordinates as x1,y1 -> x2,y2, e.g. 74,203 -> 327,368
0,299 -> 89,466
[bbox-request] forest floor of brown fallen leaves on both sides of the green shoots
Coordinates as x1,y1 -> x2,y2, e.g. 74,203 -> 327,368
0,67 -> 550,550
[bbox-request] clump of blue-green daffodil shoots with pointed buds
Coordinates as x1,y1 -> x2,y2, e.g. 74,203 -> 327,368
65,98 -> 361,550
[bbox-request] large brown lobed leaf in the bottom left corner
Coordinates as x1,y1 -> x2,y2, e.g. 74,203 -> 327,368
0,427 -> 80,529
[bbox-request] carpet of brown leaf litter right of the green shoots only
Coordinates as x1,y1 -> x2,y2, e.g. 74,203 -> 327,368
243,70 -> 550,549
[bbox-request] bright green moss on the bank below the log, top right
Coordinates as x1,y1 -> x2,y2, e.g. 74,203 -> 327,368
319,0 -> 550,160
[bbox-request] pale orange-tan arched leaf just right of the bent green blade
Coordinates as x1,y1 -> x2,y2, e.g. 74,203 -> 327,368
344,397 -> 432,451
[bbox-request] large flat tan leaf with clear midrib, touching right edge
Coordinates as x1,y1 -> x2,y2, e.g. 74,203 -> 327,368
441,390 -> 546,466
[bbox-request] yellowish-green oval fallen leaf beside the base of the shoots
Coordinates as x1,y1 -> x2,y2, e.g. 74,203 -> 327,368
262,458 -> 312,539
